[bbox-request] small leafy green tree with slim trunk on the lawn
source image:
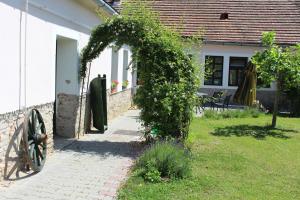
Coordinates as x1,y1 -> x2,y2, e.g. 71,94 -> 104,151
251,32 -> 300,128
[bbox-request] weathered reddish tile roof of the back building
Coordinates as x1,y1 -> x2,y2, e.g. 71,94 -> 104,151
108,0 -> 300,45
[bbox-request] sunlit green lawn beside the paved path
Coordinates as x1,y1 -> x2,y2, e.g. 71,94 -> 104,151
119,115 -> 300,200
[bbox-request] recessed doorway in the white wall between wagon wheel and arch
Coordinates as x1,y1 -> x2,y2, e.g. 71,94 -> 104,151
53,36 -> 80,138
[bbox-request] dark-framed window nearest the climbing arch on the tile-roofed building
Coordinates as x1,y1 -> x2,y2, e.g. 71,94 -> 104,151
204,56 -> 224,85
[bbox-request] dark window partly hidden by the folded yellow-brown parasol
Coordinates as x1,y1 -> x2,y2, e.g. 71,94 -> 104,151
228,57 -> 248,86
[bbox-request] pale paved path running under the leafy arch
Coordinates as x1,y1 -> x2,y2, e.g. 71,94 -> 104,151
0,111 -> 141,200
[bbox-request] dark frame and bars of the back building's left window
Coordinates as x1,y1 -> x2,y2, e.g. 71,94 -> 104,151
204,55 -> 224,86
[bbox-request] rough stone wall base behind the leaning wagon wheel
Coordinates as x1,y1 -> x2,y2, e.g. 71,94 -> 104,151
0,103 -> 54,181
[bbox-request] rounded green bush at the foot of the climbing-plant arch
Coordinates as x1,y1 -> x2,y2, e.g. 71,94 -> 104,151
135,142 -> 190,182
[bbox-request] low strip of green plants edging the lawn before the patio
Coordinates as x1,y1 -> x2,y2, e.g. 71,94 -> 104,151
204,108 -> 262,119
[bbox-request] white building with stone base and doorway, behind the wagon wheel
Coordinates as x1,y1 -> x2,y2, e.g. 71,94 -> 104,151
0,0 -> 134,181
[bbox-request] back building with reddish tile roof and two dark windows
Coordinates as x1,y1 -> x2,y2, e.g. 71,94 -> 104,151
108,0 -> 300,108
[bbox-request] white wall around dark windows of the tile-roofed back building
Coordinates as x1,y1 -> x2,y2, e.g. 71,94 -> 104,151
199,44 -> 275,105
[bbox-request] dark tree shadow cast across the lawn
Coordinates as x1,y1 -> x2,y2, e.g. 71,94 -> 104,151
211,125 -> 297,139
